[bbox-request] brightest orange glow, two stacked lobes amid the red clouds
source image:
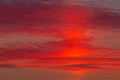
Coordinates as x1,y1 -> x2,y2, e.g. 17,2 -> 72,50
62,26 -> 92,57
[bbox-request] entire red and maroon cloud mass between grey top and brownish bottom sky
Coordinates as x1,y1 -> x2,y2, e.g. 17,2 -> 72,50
0,1 -> 120,71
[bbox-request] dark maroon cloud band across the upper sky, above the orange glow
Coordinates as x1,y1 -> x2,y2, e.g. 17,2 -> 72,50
0,2 -> 120,32
